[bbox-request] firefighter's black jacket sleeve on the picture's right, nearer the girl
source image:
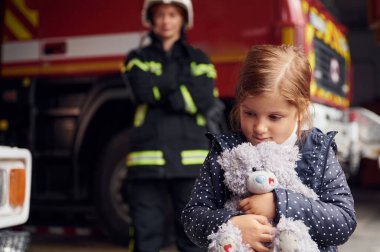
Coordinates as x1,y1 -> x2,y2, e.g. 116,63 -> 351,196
168,49 -> 216,115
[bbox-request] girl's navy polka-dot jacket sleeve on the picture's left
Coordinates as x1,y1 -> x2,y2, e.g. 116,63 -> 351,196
182,140 -> 240,248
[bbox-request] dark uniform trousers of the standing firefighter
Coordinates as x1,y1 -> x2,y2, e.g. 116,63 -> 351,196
128,179 -> 203,252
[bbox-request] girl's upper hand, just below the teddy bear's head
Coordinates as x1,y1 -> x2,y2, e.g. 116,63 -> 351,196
239,192 -> 276,220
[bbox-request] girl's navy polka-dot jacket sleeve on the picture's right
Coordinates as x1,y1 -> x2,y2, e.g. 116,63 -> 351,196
275,147 -> 356,247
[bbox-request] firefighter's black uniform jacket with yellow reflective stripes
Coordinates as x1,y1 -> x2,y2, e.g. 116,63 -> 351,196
124,33 -> 216,178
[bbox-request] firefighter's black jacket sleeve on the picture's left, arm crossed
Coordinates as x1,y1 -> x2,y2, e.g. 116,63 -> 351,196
122,50 -> 176,105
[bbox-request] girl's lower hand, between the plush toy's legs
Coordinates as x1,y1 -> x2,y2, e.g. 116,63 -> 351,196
230,214 -> 274,252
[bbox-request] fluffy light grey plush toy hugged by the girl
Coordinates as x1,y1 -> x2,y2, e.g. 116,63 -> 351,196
208,142 -> 319,252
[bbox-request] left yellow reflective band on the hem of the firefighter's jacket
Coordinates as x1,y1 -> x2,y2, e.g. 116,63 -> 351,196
127,150 -> 165,167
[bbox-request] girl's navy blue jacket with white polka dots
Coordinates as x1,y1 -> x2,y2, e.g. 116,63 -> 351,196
182,128 -> 356,251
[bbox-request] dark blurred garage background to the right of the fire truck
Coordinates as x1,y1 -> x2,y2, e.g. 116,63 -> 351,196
323,0 -> 380,107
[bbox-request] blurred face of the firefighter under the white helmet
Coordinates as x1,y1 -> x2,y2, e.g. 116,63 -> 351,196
153,4 -> 184,40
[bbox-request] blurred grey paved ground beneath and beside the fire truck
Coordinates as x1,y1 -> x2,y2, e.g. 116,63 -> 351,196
18,184 -> 380,252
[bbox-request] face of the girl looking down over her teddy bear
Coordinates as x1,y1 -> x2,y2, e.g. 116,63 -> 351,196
239,92 -> 298,145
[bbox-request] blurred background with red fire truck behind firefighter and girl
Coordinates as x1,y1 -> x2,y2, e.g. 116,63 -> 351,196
0,0 -> 380,252
